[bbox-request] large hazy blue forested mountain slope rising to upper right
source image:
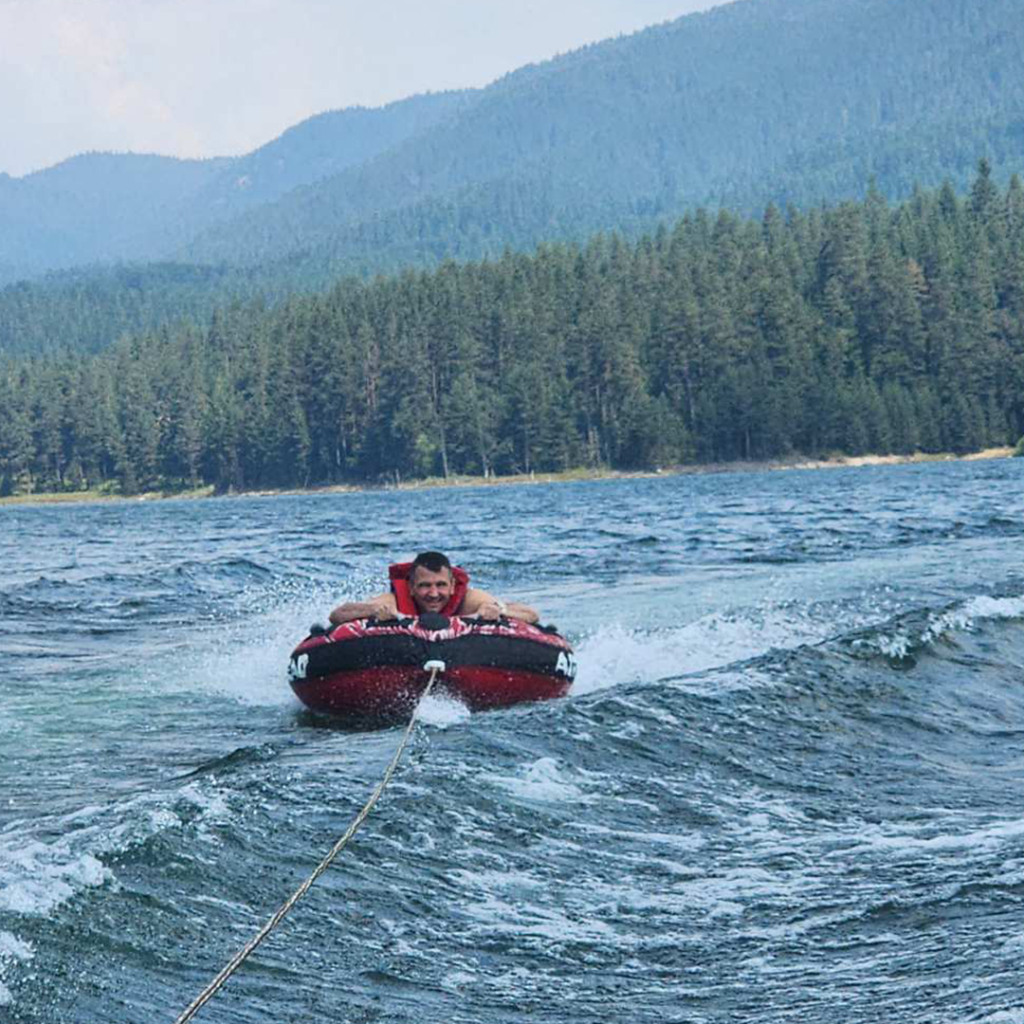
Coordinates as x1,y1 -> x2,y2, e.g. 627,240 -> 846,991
184,0 -> 1024,263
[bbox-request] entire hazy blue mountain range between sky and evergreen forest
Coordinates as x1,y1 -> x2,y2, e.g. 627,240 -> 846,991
6,0 -> 1024,351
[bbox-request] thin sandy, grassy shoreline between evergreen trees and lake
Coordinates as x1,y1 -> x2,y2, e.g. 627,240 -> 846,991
0,446 -> 1014,508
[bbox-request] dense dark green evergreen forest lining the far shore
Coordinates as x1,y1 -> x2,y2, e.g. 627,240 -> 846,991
0,162 -> 1024,494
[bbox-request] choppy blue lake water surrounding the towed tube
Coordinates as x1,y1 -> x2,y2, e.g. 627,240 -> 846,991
0,460 -> 1024,1024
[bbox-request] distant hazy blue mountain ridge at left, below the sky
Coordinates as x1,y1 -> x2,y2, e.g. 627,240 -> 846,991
0,92 -> 472,283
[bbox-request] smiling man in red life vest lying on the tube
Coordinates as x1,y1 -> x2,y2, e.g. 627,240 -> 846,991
331,551 -> 540,626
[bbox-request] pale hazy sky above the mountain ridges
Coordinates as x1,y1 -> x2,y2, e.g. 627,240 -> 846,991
0,0 -> 722,175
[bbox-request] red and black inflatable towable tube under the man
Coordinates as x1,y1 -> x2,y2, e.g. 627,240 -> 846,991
288,614 -> 577,719
